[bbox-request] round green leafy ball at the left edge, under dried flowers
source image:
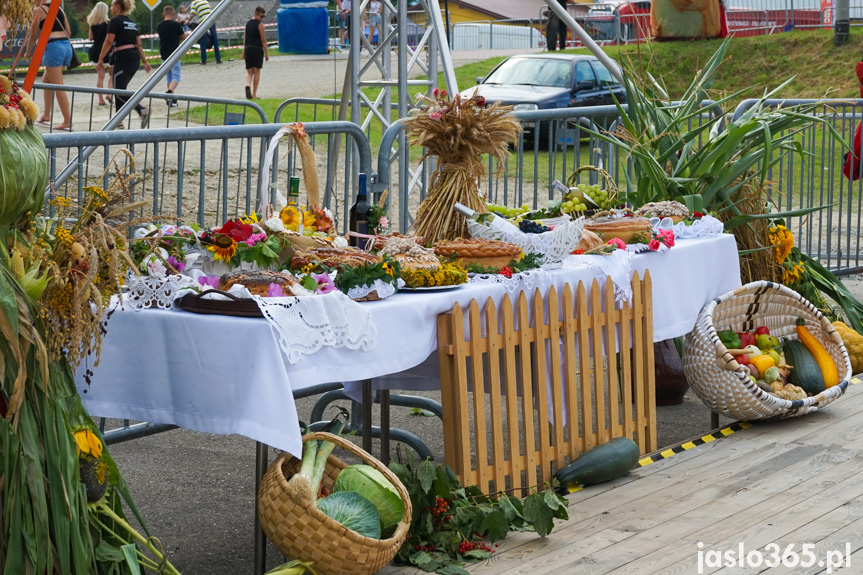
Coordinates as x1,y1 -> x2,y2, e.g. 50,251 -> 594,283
0,124 -> 48,225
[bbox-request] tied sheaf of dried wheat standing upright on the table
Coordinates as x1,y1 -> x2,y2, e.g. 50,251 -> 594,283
405,89 -> 521,244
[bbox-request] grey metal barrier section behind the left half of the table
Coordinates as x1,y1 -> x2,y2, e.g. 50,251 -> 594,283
45,122 -> 372,231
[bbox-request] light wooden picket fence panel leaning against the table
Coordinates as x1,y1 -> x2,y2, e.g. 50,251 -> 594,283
438,272 -> 656,493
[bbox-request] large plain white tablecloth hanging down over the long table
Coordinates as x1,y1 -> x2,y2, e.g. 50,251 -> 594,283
78,235 -> 740,456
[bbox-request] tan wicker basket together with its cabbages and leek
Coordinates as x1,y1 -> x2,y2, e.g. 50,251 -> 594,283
258,432 -> 411,575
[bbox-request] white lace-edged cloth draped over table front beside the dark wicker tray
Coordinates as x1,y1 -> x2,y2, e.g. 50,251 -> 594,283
252,291 -> 378,363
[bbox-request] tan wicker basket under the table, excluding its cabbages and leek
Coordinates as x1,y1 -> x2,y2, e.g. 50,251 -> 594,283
258,432 -> 411,575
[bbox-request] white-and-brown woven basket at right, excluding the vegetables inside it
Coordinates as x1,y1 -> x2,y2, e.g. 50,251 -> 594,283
683,281 -> 851,421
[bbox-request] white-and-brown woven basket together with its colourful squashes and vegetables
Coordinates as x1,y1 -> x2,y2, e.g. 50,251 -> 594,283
683,281 -> 851,421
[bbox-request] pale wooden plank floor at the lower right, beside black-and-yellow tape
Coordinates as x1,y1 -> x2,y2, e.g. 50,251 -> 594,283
384,384 -> 863,575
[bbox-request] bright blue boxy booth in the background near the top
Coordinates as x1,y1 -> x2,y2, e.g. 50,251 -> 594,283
279,0 -> 330,54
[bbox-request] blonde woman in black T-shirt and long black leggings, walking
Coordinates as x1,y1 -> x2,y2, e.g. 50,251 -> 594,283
96,0 -> 153,129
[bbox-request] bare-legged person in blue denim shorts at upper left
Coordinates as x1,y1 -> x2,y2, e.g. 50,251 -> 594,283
26,0 -> 72,132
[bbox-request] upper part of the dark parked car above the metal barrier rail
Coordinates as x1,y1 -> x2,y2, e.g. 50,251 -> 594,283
461,54 -> 626,110
